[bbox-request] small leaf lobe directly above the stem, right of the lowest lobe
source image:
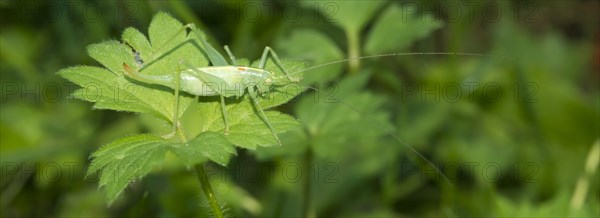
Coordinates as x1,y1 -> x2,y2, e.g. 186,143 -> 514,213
172,131 -> 235,166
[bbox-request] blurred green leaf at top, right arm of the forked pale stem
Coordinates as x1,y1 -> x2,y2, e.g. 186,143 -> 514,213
364,5 -> 442,54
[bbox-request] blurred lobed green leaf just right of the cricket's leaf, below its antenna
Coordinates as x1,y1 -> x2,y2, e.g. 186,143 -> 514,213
296,72 -> 391,157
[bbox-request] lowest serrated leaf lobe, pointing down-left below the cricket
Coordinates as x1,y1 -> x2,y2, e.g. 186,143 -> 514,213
87,135 -> 171,204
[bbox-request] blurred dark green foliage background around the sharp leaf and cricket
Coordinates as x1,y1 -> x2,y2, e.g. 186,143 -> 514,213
0,0 -> 600,217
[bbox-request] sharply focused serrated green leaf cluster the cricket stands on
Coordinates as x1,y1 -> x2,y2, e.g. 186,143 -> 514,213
58,13 -> 302,202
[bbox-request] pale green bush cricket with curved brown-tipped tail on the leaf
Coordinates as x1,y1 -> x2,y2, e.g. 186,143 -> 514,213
123,24 -> 299,145
